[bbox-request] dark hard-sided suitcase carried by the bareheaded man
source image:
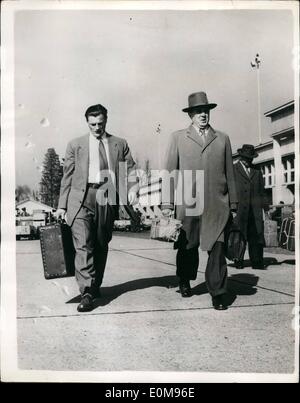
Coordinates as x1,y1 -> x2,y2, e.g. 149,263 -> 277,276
40,223 -> 75,279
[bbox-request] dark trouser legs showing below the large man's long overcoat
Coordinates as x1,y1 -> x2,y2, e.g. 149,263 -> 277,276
176,241 -> 227,297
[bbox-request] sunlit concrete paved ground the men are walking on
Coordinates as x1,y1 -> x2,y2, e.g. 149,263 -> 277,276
17,233 -> 295,380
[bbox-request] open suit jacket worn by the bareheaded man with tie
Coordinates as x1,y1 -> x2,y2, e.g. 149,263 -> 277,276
58,133 -> 136,226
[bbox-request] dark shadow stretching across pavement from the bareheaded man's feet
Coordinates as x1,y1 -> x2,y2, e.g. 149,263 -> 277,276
66,276 -> 178,308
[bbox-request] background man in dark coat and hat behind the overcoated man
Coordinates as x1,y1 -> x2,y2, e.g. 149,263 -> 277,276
234,144 -> 268,269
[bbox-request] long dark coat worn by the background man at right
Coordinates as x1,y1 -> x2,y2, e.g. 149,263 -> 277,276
234,161 -> 267,243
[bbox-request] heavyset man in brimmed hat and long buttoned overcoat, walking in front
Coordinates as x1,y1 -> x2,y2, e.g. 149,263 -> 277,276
162,92 -> 237,310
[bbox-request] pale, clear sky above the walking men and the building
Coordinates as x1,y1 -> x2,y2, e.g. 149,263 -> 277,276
14,6 -> 294,189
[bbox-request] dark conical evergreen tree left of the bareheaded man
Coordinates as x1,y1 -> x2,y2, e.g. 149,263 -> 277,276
40,148 -> 63,208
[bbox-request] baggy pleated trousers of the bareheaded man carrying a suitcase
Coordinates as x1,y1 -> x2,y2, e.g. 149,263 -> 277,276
71,188 -> 116,295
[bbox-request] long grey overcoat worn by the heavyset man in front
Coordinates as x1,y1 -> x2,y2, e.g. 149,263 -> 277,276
162,125 -> 237,250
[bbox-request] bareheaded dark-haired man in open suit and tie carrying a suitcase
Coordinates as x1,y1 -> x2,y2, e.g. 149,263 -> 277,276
56,104 -> 136,312
